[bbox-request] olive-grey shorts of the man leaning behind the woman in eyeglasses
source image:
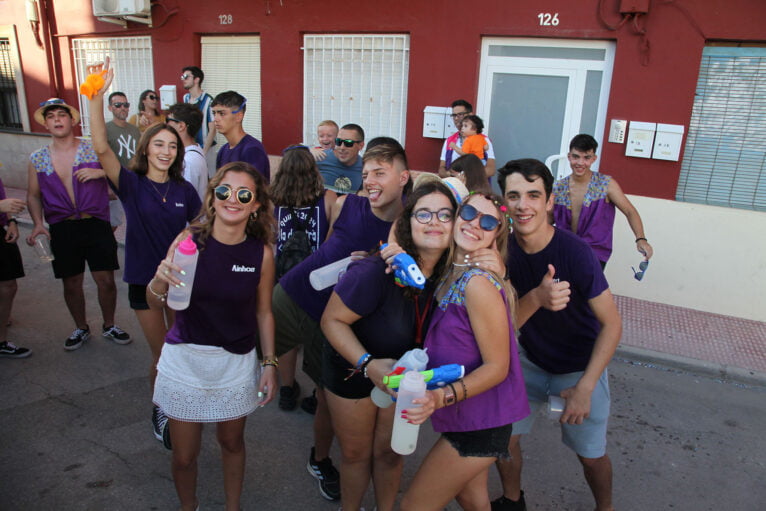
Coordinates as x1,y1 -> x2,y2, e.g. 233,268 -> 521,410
271,284 -> 324,387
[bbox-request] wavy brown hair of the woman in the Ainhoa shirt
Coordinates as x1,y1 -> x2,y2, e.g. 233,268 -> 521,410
189,161 -> 276,250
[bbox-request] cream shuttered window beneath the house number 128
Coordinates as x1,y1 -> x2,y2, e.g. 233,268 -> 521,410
202,35 -> 262,144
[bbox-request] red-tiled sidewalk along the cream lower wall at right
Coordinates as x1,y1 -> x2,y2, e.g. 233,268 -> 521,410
6,188 -> 766,385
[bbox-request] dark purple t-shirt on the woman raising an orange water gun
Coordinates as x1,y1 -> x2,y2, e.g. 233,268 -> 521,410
112,167 -> 202,286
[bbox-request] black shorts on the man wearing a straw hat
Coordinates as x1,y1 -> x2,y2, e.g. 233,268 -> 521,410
49,218 -> 120,279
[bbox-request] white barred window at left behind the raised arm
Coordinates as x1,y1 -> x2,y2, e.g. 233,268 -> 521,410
72,36 -> 157,135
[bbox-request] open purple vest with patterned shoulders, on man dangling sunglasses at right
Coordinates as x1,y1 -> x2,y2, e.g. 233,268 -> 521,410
553,172 -> 614,263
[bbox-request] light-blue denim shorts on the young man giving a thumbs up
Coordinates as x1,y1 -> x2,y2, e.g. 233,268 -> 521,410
513,349 -> 610,458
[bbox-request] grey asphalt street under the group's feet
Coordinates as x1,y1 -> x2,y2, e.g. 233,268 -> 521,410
0,226 -> 766,511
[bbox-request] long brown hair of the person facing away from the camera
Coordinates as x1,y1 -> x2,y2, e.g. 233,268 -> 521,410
271,147 -> 324,208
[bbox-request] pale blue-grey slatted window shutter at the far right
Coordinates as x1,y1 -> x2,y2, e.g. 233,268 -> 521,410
676,46 -> 766,211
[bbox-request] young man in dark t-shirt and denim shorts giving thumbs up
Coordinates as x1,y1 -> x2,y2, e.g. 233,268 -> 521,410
492,159 -> 622,511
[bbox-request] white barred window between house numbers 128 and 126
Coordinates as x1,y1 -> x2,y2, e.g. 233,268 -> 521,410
303,34 -> 410,143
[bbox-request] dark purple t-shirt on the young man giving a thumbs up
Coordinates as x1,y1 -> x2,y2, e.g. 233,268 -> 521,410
508,228 -> 609,374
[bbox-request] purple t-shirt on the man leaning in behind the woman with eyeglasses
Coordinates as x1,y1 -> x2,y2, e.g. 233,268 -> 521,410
279,195 -> 391,322
